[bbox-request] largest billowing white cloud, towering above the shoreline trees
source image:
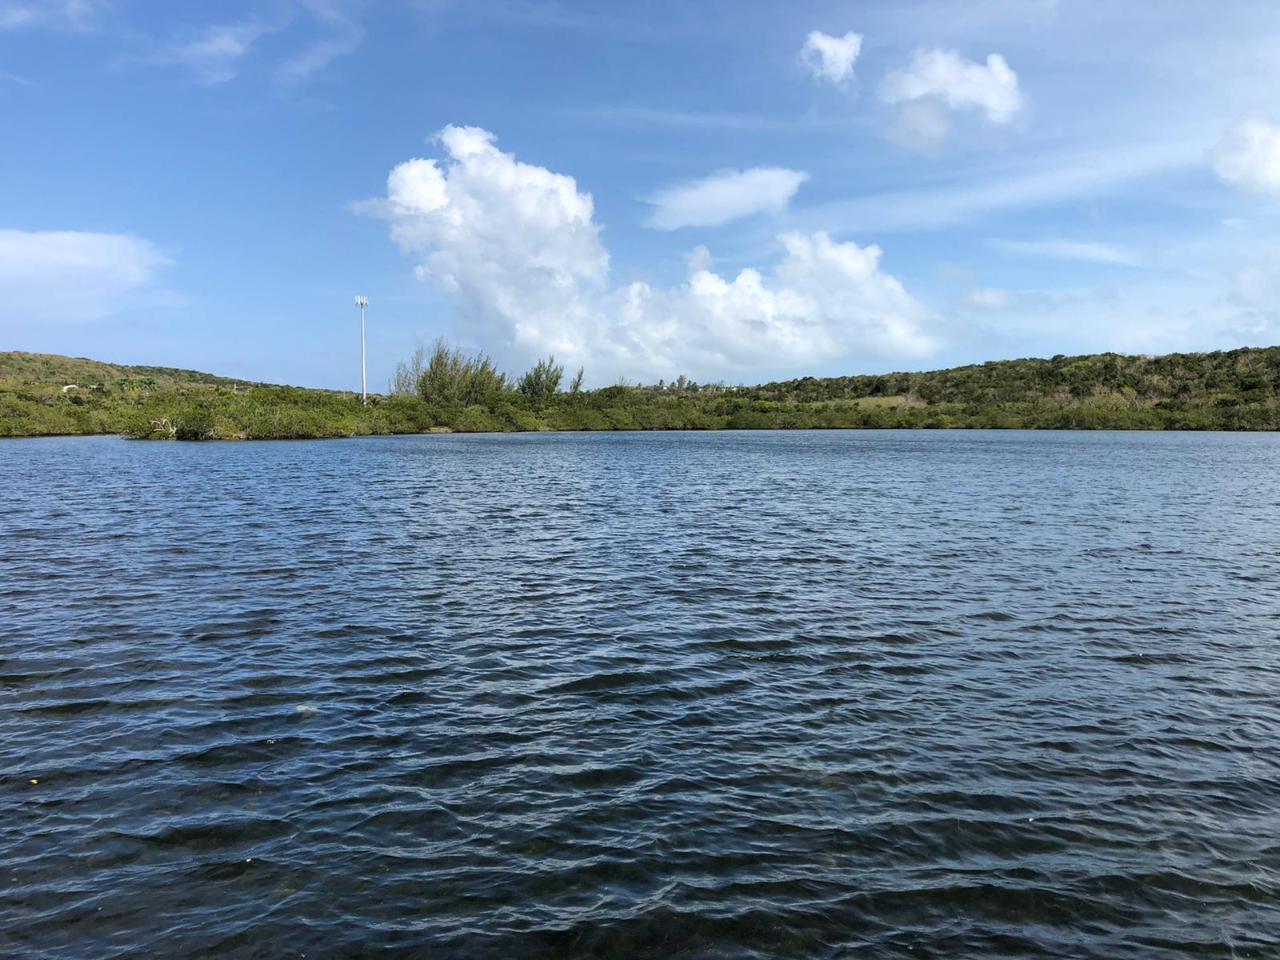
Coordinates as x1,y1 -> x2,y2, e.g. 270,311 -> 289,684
358,127 -> 933,381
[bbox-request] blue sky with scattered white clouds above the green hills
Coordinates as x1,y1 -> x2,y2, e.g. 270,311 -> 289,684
0,0 -> 1280,389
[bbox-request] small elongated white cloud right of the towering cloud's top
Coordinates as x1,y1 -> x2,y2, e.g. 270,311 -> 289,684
649,166 -> 809,230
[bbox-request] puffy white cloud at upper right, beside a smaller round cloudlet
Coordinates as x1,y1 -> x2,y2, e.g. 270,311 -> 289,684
879,50 -> 1024,147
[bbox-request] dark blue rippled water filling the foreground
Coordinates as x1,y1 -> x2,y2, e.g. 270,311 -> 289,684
0,433 -> 1280,960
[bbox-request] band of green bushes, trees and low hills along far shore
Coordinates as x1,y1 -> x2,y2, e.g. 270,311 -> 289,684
0,342 -> 1280,439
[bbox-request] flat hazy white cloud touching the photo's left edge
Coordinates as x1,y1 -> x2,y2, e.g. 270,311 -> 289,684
0,230 -> 172,324
